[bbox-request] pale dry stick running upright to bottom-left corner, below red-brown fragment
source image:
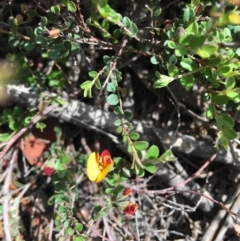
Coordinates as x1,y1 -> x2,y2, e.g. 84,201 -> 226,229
2,149 -> 18,241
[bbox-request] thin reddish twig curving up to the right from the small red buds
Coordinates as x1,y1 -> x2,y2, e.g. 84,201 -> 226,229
151,153 -> 217,195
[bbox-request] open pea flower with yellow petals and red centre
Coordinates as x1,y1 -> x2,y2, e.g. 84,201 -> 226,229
87,150 -> 114,183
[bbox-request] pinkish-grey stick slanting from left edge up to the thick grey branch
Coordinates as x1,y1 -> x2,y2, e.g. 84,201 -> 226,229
0,104 -> 58,160
